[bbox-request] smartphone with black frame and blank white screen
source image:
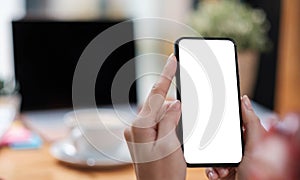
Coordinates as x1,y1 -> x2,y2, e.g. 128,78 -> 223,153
175,37 -> 244,167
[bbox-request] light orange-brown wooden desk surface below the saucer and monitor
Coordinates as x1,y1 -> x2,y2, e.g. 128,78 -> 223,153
0,124 -> 207,180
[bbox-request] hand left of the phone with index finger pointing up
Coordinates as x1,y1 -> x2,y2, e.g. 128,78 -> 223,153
124,55 -> 186,180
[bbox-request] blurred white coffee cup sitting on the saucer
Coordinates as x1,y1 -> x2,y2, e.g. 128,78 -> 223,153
64,109 -> 126,156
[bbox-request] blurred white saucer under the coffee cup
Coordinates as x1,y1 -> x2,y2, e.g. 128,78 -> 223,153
50,139 -> 132,167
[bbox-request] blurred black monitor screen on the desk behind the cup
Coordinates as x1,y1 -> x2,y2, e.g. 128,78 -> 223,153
12,20 -> 136,111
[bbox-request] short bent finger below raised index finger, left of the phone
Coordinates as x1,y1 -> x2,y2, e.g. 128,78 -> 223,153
157,100 -> 181,139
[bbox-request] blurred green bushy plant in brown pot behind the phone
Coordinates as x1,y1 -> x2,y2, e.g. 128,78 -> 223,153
190,0 -> 271,97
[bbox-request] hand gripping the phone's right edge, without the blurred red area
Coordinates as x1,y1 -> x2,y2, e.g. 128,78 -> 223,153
206,96 -> 267,180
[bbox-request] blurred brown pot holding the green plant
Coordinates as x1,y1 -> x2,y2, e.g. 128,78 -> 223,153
238,50 -> 259,98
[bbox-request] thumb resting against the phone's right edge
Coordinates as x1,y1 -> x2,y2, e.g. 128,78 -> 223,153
241,95 -> 266,151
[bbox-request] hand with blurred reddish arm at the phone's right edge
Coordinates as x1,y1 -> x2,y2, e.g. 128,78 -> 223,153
206,97 -> 300,180
